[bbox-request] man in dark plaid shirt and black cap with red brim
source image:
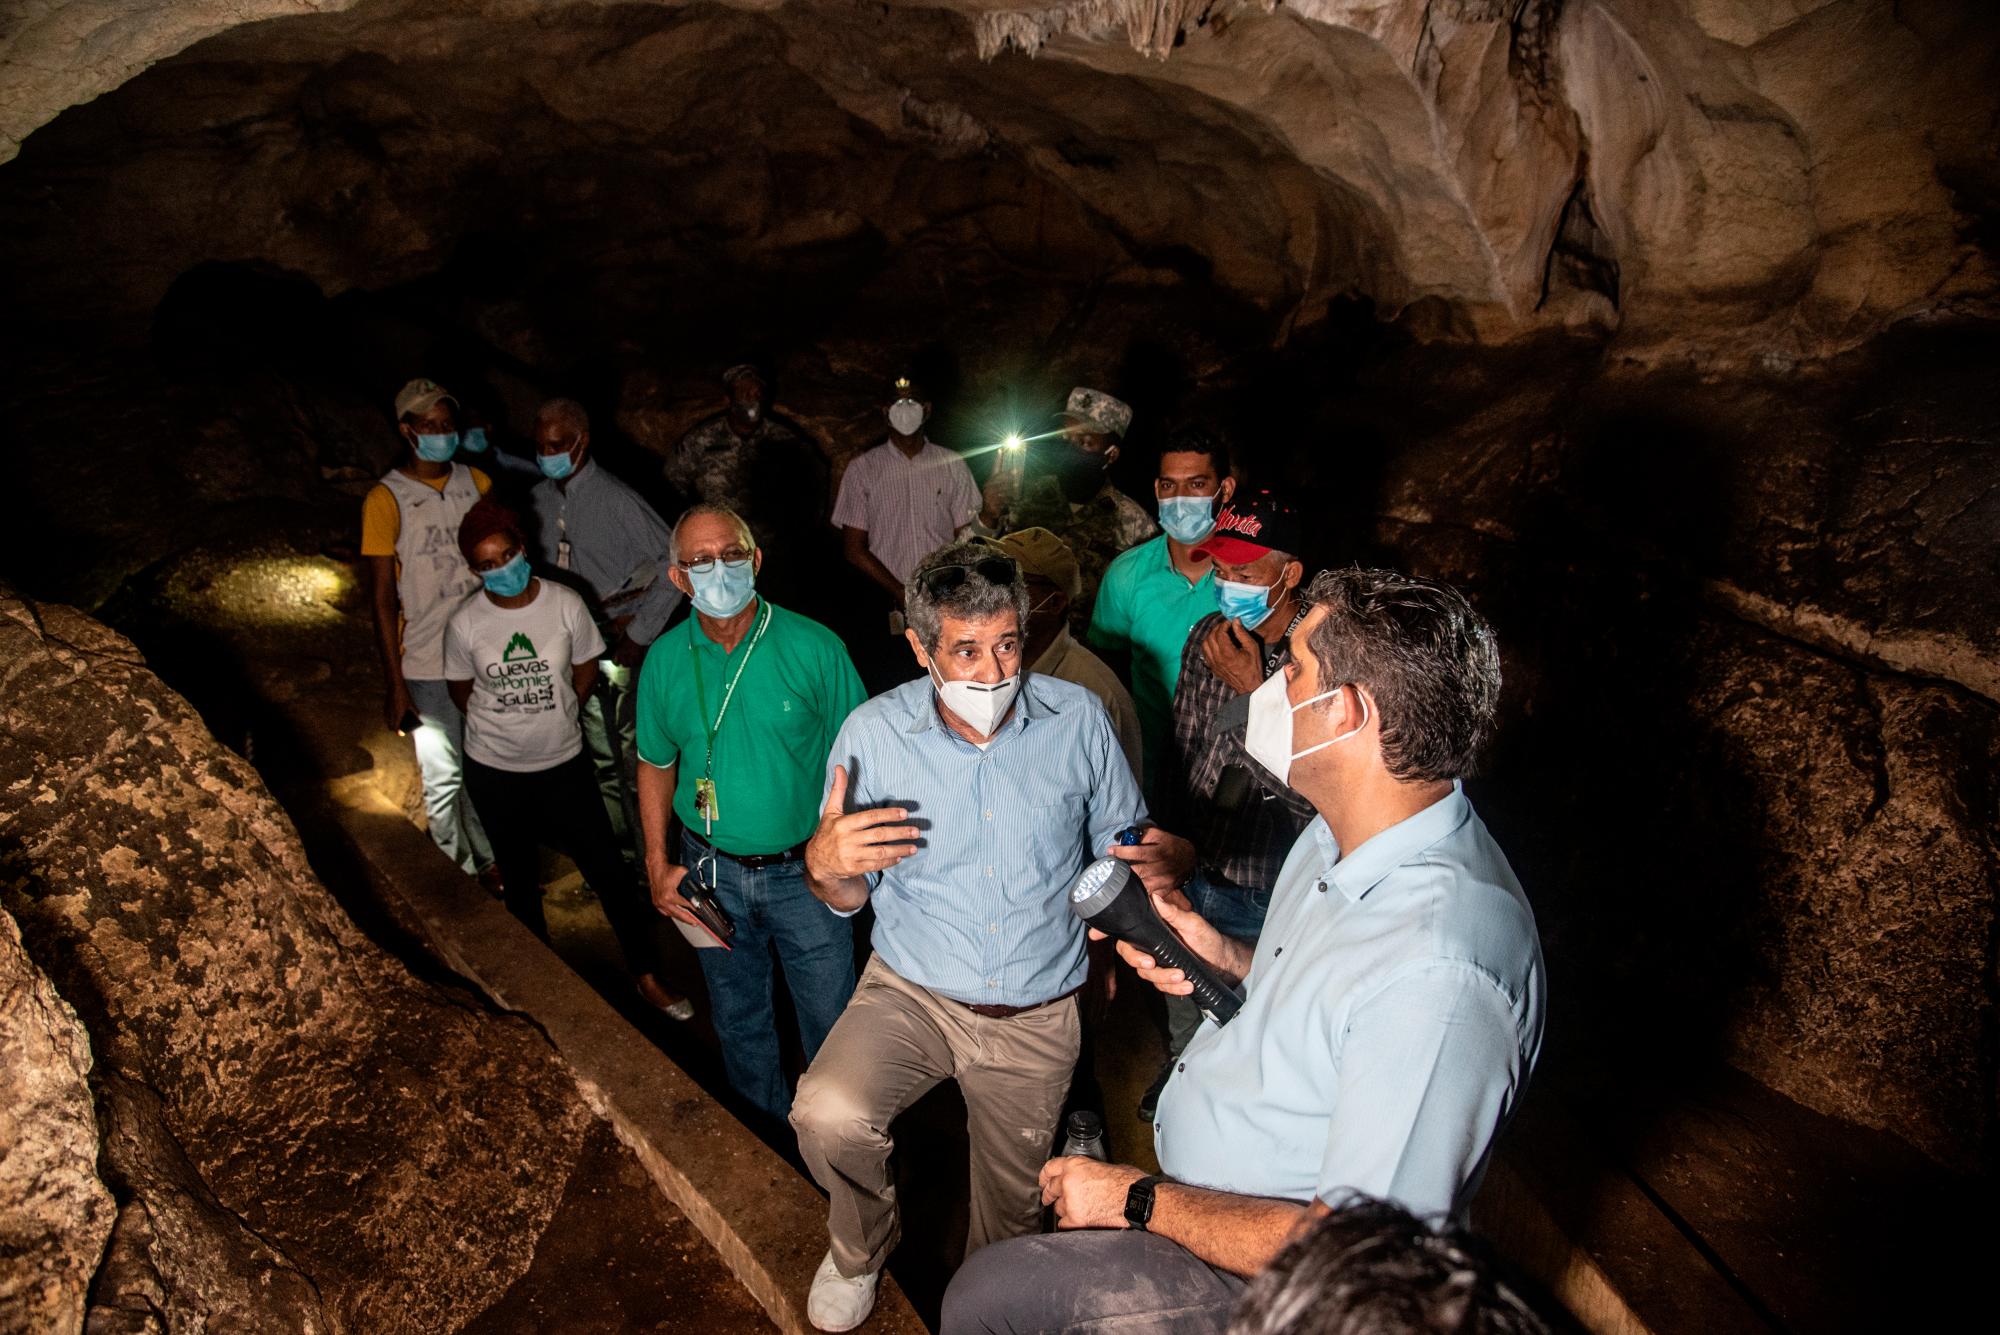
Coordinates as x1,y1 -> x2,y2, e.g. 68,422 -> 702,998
1138,492 -> 1312,1121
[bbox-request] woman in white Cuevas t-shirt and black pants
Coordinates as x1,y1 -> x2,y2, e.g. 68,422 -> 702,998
444,500 -> 694,1019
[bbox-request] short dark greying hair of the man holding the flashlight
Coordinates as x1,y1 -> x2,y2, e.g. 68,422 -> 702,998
1306,568 -> 1500,781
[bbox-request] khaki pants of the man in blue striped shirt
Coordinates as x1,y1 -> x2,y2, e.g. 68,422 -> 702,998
792,957 -> 1082,1279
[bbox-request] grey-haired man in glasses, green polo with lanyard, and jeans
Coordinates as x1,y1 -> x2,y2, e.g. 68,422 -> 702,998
638,506 -> 866,1123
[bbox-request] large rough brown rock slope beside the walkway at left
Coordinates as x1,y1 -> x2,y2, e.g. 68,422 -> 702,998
0,594 -> 594,1331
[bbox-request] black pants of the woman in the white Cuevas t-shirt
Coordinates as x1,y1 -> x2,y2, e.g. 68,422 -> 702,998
466,751 -> 666,977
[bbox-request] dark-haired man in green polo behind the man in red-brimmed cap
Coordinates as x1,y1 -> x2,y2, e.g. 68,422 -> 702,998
1084,428 -> 1236,793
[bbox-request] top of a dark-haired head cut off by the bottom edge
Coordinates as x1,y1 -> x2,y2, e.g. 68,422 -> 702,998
1228,1195 -> 1570,1335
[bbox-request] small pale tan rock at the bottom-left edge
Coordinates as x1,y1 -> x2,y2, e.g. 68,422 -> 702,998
0,911 -> 112,1335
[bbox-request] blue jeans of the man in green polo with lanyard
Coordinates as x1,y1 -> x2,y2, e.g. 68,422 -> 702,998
680,833 -> 854,1121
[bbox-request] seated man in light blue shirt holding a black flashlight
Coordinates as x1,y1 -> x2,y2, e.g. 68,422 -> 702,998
944,570 -> 1544,1335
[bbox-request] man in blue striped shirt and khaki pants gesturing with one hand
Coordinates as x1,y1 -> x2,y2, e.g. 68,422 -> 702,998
792,540 -> 1146,1331
